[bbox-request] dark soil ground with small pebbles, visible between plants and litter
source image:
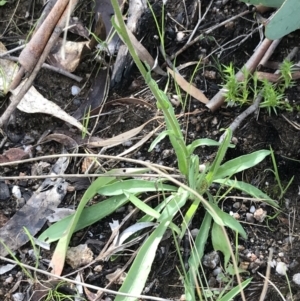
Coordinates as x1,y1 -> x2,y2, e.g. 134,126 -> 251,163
0,0 -> 300,301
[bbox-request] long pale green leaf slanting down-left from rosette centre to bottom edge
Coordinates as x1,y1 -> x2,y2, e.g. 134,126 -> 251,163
115,189 -> 189,301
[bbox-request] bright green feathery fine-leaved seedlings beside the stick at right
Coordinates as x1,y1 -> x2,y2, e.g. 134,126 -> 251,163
222,60 -> 294,115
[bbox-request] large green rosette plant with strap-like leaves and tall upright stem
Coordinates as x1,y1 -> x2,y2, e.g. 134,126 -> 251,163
40,0 -> 278,301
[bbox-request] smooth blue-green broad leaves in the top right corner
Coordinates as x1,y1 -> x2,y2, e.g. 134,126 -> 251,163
241,0 -> 300,40
